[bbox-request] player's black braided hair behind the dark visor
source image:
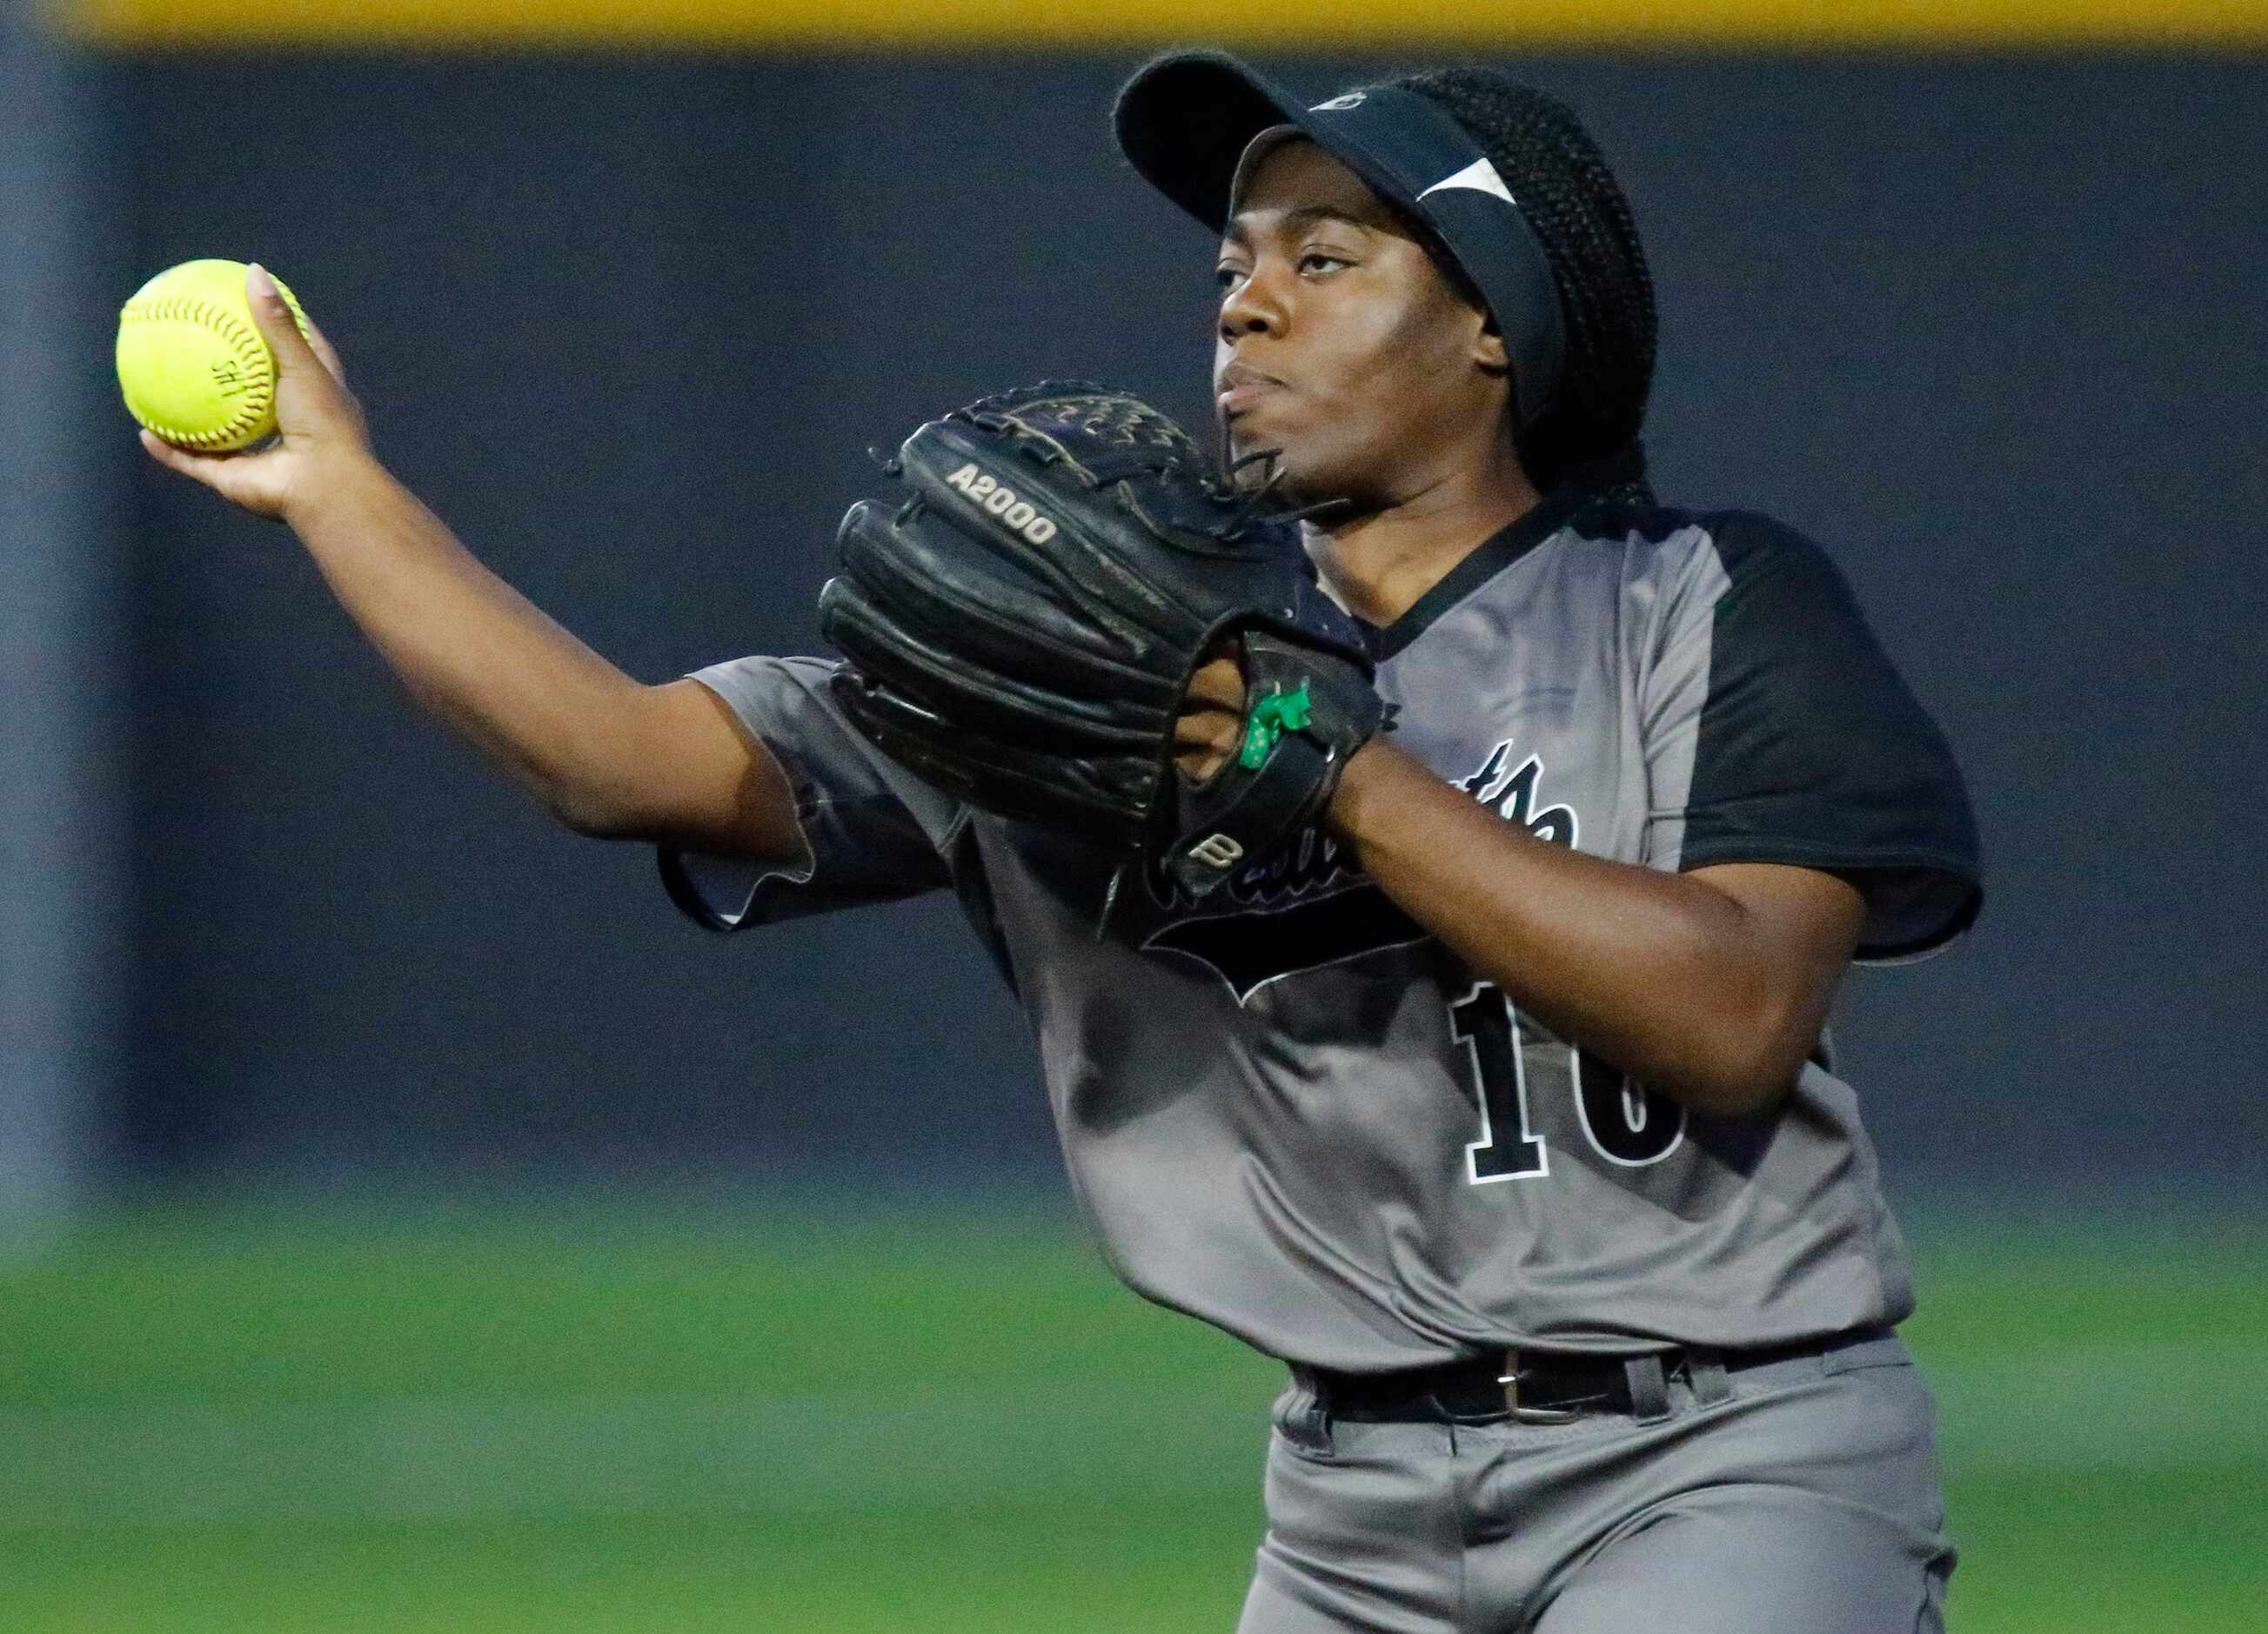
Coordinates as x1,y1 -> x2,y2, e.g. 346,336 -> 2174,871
1395,68 -> 1656,492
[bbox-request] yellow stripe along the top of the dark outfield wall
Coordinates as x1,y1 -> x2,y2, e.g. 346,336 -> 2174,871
50,0 -> 2268,50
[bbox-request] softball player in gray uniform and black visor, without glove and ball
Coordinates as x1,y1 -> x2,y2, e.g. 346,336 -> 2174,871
152,57 -> 1980,1634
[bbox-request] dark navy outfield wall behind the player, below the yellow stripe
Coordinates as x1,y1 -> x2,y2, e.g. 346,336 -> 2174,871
102,55 -> 2268,1187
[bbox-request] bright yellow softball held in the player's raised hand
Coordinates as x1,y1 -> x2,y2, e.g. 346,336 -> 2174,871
118,261 -> 306,454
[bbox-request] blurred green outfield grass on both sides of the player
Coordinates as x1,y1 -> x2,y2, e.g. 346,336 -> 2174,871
0,1198 -> 2268,1634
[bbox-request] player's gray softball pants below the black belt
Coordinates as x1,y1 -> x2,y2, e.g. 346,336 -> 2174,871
1238,1336 -> 1953,1634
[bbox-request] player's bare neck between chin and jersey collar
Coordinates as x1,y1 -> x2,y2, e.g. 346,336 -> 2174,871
1307,460 -> 1538,629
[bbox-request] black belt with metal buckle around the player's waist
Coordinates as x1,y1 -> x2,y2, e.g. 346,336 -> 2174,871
1297,1328 -> 1890,1423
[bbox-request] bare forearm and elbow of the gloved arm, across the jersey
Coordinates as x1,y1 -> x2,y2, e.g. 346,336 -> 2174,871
1331,742 -> 1830,1116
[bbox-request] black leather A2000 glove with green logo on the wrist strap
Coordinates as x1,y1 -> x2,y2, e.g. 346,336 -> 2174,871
819,381 -> 1386,896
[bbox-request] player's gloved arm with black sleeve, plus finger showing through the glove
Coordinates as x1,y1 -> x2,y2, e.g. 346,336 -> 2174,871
1177,512 -> 1983,1116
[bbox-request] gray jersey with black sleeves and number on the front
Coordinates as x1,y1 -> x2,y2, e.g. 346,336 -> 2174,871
662,479 -> 1980,1370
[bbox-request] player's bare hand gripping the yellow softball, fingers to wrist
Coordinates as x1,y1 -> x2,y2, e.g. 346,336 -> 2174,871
141,265 -> 370,522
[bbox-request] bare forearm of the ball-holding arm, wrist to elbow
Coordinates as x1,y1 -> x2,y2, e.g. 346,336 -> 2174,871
291,459 -> 680,833
